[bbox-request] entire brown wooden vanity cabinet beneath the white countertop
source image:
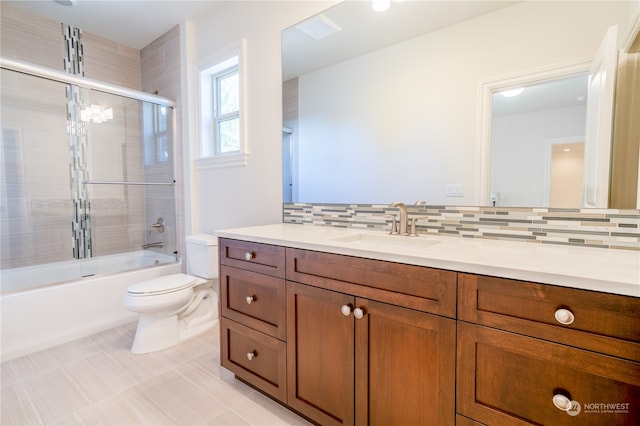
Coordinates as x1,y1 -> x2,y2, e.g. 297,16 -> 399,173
219,238 -> 640,426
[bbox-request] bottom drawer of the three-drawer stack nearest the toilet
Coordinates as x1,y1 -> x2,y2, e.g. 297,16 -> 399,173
220,318 -> 287,402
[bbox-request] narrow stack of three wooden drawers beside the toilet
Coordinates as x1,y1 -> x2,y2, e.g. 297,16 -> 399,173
219,238 -> 286,402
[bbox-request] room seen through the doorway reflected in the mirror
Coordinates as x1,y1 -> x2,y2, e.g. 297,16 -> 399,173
489,72 -> 587,208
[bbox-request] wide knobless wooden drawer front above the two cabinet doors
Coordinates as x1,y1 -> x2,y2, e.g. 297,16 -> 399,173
286,248 -> 456,318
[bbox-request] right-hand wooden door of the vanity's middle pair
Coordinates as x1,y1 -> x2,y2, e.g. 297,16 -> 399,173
355,299 -> 456,426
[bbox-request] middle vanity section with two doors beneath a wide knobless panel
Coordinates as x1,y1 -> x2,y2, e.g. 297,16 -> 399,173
286,249 -> 456,425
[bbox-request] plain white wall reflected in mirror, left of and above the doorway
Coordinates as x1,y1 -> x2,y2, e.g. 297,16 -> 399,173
298,2 -> 629,205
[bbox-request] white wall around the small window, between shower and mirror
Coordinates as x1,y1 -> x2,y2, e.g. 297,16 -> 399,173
184,1 -> 335,233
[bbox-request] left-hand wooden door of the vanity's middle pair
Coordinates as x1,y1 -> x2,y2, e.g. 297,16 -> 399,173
287,281 -> 355,425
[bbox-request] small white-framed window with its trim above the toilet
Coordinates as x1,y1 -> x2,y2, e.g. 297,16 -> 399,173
196,41 -> 248,168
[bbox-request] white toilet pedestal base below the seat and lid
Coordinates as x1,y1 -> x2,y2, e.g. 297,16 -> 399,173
131,290 -> 218,354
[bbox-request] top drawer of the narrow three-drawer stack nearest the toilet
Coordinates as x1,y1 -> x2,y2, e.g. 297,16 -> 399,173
220,238 -> 284,277
